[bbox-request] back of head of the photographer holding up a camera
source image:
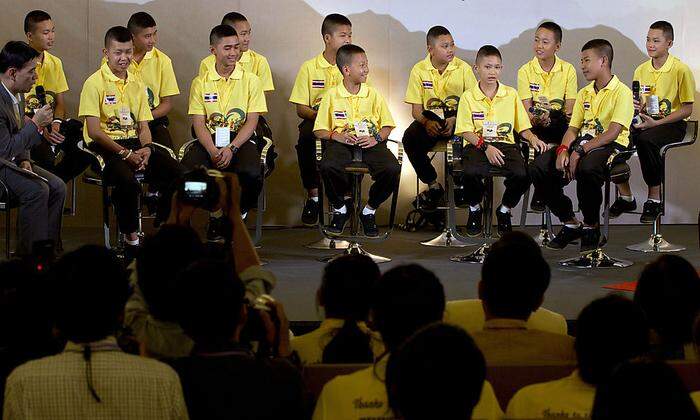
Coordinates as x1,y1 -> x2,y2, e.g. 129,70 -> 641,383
136,225 -> 205,321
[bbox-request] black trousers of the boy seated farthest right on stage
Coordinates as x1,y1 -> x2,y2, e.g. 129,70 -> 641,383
630,121 -> 687,187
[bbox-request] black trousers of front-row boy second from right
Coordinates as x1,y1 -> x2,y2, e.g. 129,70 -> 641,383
462,143 -> 530,208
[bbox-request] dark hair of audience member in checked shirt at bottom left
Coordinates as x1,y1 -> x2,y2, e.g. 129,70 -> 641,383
52,245 -> 131,343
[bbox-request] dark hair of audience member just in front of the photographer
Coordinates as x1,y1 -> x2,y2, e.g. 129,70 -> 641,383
176,259 -> 245,346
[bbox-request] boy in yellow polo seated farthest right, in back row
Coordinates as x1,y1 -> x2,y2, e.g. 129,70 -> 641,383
610,21 -> 695,224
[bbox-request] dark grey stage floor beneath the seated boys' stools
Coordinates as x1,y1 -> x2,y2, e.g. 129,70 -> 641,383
3,225 -> 700,321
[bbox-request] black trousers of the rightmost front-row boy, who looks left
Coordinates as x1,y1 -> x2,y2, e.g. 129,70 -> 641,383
529,143 -> 620,226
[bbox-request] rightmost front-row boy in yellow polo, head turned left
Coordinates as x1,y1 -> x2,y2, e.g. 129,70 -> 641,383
530,39 -> 634,252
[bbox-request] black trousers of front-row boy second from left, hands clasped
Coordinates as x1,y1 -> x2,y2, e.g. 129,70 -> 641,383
182,137 -> 263,212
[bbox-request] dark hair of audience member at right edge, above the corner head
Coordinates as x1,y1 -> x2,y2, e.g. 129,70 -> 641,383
634,255 -> 700,348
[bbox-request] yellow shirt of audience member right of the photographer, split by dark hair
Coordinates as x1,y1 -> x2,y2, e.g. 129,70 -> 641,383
291,318 -> 384,365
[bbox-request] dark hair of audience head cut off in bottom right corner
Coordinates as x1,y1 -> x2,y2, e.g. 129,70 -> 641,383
591,360 -> 700,420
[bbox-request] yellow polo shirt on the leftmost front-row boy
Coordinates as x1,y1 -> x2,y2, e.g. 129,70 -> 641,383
78,63 -> 153,143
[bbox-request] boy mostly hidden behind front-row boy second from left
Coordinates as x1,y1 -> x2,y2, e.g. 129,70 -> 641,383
199,12 -> 275,92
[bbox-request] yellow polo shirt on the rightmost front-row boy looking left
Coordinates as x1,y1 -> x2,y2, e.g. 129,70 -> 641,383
569,76 -> 634,147
